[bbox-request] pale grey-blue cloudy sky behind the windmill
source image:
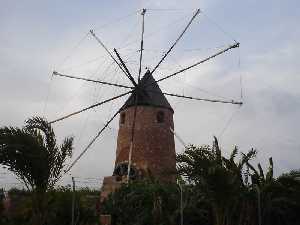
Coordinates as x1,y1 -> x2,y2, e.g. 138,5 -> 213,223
0,0 -> 300,186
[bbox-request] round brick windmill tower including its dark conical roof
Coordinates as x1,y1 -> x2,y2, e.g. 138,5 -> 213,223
101,71 -> 176,198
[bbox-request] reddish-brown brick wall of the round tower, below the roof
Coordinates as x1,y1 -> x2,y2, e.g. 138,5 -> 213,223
115,106 -> 176,182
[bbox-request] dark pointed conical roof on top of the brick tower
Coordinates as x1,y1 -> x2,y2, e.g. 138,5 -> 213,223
122,71 -> 173,112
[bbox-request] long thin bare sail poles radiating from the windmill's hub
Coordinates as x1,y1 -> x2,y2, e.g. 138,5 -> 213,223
50,9 -> 243,185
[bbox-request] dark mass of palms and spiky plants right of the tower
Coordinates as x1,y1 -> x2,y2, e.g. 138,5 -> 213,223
177,138 -> 300,225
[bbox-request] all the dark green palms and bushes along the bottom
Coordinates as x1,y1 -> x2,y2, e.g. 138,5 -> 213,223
0,117 -> 300,225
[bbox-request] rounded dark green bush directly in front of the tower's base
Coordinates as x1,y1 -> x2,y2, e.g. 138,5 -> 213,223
100,179 -> 180,225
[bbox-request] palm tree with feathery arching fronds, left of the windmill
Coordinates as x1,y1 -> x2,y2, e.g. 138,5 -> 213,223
0,117 -> 73,225
